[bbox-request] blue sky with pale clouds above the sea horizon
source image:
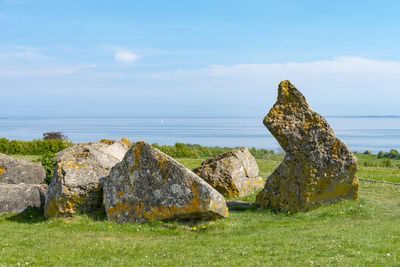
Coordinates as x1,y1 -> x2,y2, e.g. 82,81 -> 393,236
0,0 -> 400,117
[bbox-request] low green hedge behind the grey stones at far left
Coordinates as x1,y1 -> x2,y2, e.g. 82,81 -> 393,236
0,138 -> 72,155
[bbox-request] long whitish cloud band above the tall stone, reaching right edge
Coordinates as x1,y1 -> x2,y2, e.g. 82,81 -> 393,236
149,57 -> 400,80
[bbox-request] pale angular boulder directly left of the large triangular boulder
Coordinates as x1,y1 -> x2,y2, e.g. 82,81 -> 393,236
44,138 -> 131,217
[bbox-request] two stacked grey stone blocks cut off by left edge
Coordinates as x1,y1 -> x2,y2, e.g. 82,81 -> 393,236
0,154 -> 47,213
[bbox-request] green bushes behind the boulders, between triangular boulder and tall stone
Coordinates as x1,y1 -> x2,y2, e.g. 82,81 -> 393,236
153,143 -> 274,159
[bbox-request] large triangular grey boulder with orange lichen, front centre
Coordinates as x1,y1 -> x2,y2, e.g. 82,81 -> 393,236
103,141 -> 228,223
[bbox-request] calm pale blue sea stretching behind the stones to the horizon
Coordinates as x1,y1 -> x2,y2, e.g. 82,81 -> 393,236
0,116 -> 400,152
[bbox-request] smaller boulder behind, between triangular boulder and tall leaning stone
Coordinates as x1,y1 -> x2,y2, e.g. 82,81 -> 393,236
193,148 -> 264,196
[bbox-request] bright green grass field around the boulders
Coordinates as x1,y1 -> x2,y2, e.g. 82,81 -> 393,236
0,158 -> 400,266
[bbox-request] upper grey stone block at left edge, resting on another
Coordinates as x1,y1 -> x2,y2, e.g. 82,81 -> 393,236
0,153 -> 46,184
